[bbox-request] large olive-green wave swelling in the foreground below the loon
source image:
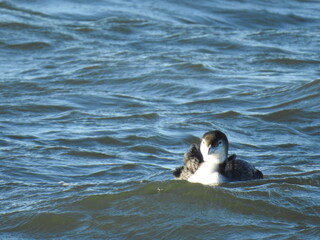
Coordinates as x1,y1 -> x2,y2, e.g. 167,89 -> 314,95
3,180 -> 319,237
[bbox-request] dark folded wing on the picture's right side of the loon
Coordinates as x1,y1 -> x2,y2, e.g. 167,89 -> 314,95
224,159 -> 263,181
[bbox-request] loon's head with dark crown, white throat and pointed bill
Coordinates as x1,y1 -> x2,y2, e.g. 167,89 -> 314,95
200,130 -> 229,164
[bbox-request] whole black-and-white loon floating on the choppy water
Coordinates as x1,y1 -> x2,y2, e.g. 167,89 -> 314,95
173,130 -> 263,185
